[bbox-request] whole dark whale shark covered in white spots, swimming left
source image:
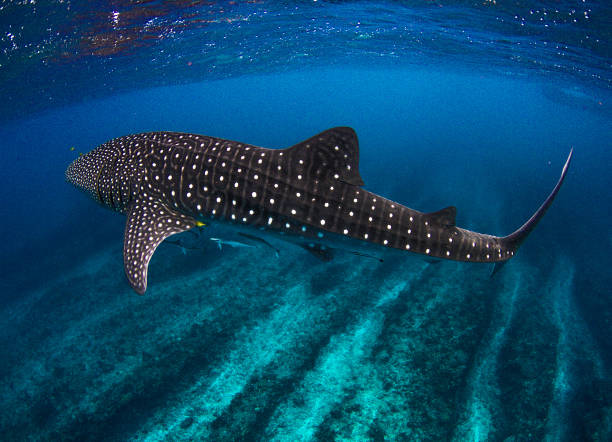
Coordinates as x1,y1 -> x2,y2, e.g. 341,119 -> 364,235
65,127 -> 572,294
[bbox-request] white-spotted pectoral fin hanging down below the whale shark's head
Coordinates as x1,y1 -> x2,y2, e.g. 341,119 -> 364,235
123,199 -> 196,295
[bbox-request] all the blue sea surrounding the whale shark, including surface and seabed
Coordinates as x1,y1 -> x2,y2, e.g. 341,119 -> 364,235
0,1 -> 612,441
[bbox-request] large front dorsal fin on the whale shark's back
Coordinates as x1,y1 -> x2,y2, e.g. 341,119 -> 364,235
285,127 -> 364,186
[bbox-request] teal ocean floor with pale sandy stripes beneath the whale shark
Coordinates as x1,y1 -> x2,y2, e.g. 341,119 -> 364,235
0,233 -> 612,441
